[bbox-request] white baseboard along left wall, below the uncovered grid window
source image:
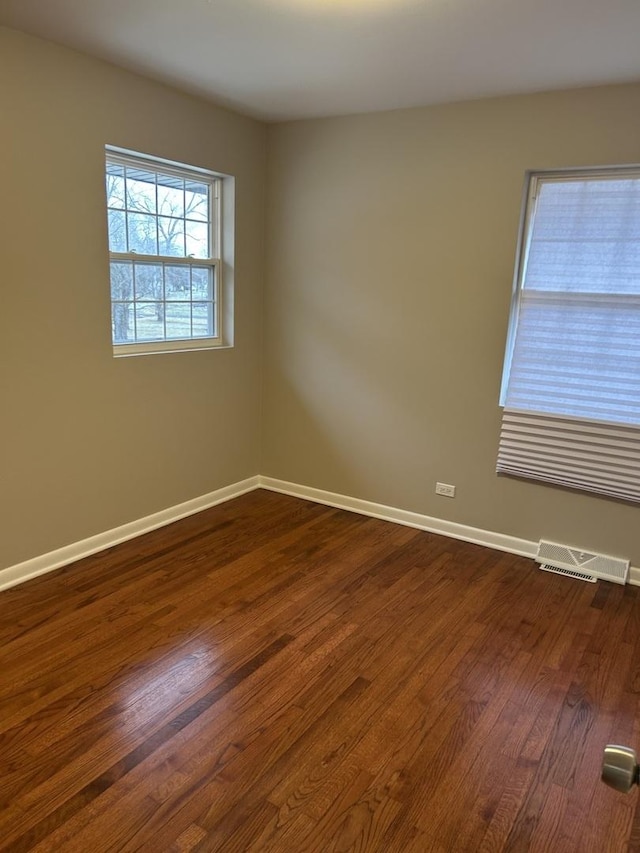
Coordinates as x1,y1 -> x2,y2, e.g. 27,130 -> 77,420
0,476 -> 260,590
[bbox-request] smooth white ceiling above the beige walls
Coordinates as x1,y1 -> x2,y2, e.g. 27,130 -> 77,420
0,0 -> 640,121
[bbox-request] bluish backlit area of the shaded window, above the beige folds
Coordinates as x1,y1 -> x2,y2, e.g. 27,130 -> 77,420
502,173 -> 640,424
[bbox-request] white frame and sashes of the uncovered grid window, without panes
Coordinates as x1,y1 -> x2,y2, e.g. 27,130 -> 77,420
105,145 -> 232,357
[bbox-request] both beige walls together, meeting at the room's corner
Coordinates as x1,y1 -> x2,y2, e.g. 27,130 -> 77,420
0,29 -> 640,580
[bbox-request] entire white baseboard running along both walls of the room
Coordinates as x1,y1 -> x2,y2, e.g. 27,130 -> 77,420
0,476 -> 640,590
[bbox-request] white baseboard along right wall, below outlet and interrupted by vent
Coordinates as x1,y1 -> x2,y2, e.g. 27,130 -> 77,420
259,477 -> 640,586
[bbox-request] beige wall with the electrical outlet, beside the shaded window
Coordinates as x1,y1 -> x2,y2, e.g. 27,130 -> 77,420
262,86 -> 640,565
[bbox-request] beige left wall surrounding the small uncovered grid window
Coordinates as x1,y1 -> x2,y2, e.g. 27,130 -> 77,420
0,29 -> 266,568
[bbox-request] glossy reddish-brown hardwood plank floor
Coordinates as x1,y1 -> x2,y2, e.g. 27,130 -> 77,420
0,491 -> 640,853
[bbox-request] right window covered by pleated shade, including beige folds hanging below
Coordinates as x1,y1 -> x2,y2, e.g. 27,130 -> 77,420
497,167 -> 640,501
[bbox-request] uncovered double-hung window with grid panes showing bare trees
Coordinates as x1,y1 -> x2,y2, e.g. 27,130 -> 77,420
106,148 -> 222,355
